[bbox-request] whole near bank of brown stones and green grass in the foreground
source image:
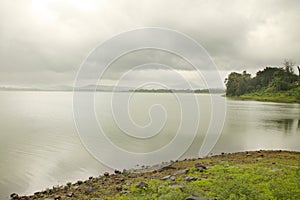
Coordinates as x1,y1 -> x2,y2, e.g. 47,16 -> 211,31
10,150 -> 300,200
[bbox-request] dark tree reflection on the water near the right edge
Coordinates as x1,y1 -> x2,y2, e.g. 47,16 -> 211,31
263,119 -> 300,134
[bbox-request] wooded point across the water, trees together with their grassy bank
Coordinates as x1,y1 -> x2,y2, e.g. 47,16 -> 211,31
225,60 -> 300,103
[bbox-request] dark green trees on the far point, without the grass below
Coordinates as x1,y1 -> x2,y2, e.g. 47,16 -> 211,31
225,60 -> 300,96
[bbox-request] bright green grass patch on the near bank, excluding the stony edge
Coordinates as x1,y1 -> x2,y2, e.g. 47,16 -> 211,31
116,159 -> 300,200
